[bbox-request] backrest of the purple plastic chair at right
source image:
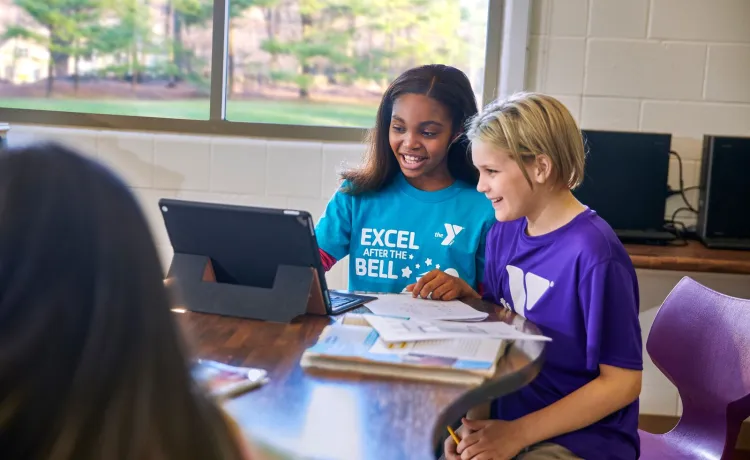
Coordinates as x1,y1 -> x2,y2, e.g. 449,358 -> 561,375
646,277 -> 750,423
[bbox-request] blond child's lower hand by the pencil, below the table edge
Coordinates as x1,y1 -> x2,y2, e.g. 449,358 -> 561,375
446,419 -> 526,460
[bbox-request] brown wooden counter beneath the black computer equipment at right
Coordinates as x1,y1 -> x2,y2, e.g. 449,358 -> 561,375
625,241 -> 750,275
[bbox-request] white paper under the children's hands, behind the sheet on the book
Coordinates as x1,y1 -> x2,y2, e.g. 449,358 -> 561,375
365,293 -> 489,321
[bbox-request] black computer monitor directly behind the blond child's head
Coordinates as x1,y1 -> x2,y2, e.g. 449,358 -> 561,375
573,130 -> 674,242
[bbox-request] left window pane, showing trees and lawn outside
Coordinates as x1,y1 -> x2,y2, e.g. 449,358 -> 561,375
0,0 -> 213,120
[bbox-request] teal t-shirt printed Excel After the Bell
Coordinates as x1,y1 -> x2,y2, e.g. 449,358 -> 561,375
315,173 -> 495,292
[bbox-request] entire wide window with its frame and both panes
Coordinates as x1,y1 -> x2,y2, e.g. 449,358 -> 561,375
0,0 -> 513,140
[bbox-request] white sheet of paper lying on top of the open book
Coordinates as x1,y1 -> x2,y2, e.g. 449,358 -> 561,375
364,315 -> 550,343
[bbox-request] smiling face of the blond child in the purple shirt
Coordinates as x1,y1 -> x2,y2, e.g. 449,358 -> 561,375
471,140 -> 540,222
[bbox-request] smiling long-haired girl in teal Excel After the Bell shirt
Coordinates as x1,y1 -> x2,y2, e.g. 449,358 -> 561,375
316,65 -> 494,300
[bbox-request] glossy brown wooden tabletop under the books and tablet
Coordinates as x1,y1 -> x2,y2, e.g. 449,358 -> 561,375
177,301 -> 544,460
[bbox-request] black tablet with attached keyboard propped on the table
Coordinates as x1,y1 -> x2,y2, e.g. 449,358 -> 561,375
159,198 -> 373,314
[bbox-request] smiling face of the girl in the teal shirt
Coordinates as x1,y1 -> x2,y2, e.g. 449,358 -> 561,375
388,94 -> 453,190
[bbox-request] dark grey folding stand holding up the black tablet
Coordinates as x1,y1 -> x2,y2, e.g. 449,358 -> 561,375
167,253 -> 327,323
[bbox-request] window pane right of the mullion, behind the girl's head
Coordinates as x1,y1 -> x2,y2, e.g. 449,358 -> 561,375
227,0 -> 489,127
